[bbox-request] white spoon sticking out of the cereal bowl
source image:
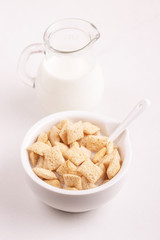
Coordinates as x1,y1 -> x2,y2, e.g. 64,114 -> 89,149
108,99 -> 150,142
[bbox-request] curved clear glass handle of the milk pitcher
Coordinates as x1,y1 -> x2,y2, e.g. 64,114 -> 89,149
17,43 -> 44,88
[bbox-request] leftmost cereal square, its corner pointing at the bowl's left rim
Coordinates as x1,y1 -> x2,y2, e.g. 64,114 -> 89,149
27,141 -> 51,156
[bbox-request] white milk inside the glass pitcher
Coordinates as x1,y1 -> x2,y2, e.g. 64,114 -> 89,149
35,55 -> 104,113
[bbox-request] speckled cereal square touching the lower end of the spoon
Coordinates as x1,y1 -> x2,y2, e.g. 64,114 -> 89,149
86,135 -> 108,152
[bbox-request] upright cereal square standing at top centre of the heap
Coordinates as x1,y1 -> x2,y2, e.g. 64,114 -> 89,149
67,121 -> 84,144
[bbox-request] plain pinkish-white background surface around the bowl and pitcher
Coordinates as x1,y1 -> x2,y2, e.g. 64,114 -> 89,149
0,0 -> 160,240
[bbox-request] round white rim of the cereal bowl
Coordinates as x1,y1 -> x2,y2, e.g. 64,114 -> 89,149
20,111 -> 132,196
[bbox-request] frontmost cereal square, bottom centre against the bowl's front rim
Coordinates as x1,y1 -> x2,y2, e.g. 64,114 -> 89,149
63,174 -> 82,190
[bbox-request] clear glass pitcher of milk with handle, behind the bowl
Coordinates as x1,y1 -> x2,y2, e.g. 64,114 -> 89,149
18,19 -> 104,113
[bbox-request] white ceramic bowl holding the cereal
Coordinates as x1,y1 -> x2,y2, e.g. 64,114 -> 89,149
21,111 -> 132,212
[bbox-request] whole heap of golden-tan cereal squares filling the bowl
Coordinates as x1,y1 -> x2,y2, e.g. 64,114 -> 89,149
27,120 -> 121,191
